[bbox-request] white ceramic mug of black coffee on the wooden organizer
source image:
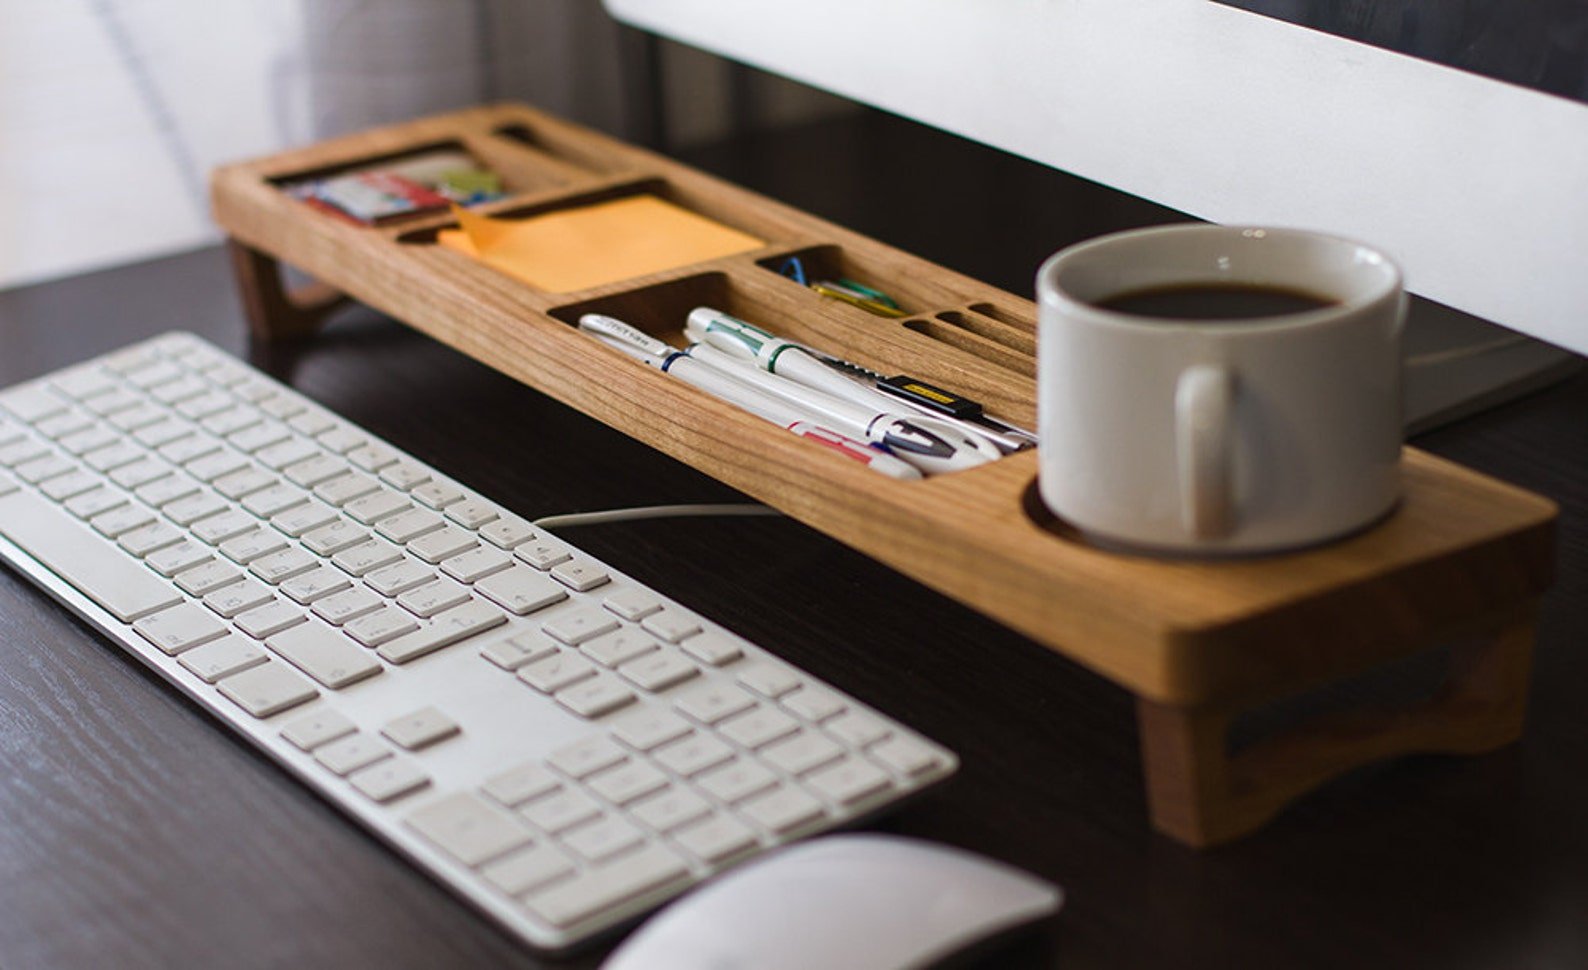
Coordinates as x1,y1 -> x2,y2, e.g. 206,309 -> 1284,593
1037,224 -> 1405,556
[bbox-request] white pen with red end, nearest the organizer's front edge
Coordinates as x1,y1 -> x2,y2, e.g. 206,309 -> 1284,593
580,313 -> 921,479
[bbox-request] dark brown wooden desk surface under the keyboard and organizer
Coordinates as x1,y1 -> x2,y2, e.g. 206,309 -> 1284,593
0,110 -> 1588,970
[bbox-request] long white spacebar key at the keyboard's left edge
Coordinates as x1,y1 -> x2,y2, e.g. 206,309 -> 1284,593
0,492 -> 183,622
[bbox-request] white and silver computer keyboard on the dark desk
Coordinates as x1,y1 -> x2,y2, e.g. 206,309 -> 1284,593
0,333 -> 956,949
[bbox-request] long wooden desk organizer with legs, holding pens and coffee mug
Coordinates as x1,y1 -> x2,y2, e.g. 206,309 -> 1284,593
213,105 -> 1555,846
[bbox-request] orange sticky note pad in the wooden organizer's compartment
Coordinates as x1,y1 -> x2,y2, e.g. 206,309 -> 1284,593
438,195 -> 764,294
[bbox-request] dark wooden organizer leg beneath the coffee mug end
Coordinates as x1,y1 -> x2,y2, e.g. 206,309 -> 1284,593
1135,605 -> 1536,848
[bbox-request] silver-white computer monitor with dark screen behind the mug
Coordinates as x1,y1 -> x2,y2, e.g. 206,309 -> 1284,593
605,0 -> 1588,369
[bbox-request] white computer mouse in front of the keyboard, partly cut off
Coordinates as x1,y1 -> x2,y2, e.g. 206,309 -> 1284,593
602,833 -> 1064,970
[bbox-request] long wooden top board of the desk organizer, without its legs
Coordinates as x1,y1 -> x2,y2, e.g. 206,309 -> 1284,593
213,105 -> 1555,720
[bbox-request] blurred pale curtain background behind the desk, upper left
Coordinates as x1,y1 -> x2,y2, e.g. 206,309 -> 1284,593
0,0 -> 856,289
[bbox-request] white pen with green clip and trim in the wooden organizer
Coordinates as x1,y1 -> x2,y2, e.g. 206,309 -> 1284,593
684,306 -> 1015,460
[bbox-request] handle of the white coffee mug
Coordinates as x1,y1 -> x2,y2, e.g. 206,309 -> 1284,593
1175,364 -> 1235,538
